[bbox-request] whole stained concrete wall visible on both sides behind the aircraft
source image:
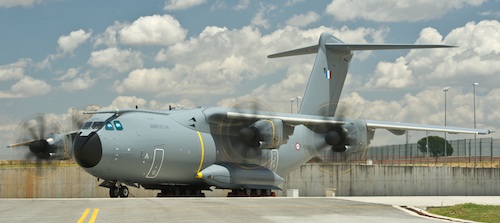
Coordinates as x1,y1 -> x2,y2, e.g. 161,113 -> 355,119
0,163 -> 500,198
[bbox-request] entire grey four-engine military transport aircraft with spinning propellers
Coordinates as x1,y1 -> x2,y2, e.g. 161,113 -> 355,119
6,33 -> 492,197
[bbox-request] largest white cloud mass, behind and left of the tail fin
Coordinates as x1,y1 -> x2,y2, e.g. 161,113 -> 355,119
146,26 -> 388,108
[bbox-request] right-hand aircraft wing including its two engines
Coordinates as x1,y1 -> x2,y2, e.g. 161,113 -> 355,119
204,109 -> 493,152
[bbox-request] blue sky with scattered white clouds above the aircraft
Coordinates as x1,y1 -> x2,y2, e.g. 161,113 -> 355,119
0,0 -> 500,156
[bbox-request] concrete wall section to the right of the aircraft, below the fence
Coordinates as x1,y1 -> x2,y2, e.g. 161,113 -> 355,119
283,163 -> 500,196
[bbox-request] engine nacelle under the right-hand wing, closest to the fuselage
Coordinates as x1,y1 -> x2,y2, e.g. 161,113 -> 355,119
239,119 -> 287,149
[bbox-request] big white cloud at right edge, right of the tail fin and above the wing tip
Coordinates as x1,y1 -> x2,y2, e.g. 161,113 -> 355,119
366,20 -> 500,88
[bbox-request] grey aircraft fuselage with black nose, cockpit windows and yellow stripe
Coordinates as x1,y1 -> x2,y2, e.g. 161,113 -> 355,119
74,108 -> 346,190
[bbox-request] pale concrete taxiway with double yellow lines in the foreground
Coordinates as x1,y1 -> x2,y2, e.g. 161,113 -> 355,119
0,197 -> 492,223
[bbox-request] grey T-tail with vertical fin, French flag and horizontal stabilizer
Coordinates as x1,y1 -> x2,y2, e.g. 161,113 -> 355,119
268,33 -> 453,116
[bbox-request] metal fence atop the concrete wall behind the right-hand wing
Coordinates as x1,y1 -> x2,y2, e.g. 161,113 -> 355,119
321,138 -> 500,168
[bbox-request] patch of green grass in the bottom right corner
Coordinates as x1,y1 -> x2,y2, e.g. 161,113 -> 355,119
427,203 -> 500,223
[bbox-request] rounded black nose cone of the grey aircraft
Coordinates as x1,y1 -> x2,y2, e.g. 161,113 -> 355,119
73,132 -> 102,168
